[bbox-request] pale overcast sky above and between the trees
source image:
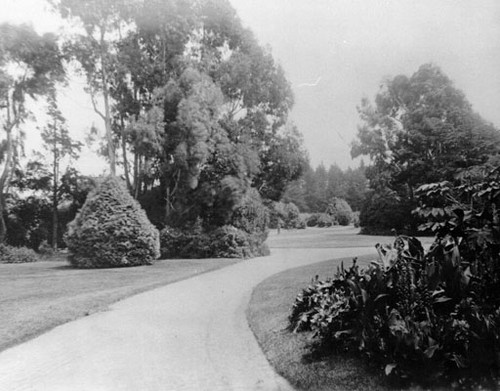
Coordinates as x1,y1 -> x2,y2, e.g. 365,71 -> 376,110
0,0 -> 500,172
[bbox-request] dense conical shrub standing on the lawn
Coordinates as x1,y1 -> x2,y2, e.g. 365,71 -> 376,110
65,176 -> 160,268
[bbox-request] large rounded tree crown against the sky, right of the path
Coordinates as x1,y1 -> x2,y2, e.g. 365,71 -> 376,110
351,64 -> 500,231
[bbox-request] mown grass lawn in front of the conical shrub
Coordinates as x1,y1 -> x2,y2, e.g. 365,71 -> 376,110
0,259 -> 239,351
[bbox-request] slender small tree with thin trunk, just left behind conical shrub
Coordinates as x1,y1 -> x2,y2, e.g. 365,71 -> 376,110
42,93 -> 82,250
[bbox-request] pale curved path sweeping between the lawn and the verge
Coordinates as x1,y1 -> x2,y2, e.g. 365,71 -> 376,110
0,234 -> 374,391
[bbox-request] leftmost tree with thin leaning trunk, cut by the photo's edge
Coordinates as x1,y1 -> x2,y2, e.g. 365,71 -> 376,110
0,24 -> 64,242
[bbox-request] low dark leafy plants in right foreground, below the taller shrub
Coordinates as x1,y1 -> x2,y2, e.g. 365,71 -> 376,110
289,228 -> 500,387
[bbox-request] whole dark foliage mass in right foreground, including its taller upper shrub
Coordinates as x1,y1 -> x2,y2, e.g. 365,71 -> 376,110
290,168 -> 500,388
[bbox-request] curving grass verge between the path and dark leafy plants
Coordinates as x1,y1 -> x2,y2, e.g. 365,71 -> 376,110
247,256 -> 389,391
